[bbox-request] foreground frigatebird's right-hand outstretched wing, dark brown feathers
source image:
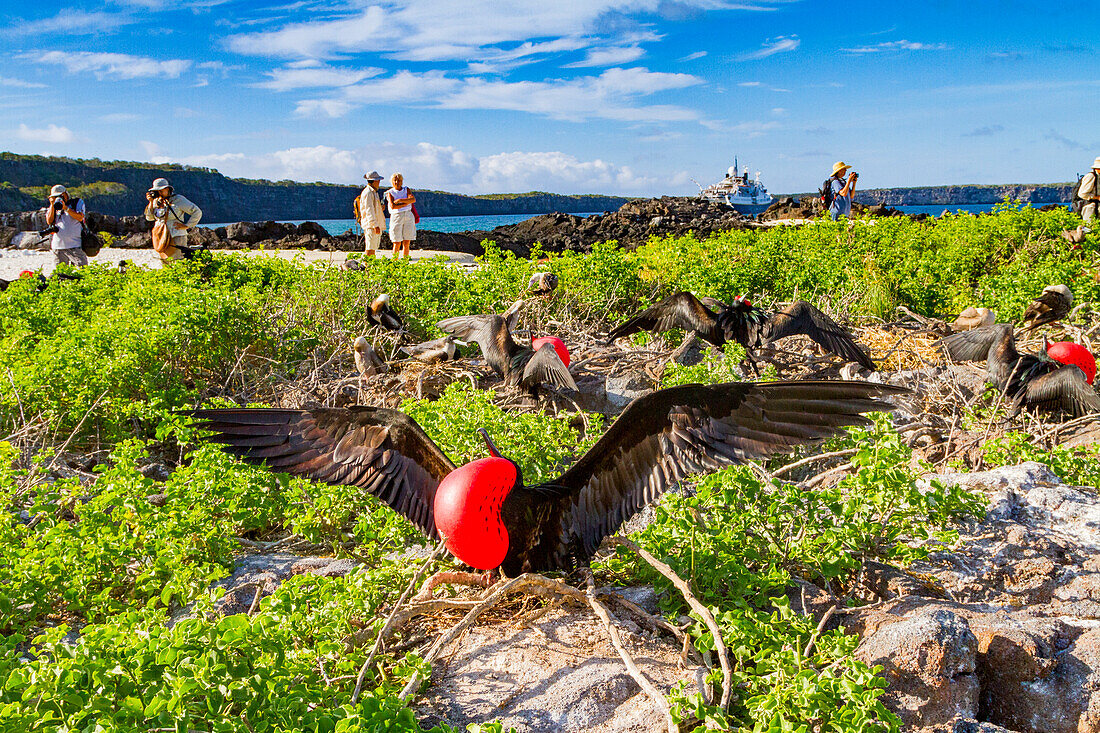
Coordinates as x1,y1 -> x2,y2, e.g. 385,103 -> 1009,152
538,381 -> 909,557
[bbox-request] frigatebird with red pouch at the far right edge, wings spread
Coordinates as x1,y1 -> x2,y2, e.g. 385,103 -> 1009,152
936,324 -> 1100,416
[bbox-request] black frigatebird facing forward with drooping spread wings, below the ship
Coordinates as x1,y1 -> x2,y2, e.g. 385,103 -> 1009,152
607,291 -> 876,371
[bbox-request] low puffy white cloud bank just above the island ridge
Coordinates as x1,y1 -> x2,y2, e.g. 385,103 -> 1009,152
151,142 -> 688,194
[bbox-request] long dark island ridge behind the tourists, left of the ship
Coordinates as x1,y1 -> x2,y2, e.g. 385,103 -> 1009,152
0,153 -> 630,222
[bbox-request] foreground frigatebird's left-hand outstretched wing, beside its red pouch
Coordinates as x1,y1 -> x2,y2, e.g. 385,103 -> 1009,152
187,407 -> 454,537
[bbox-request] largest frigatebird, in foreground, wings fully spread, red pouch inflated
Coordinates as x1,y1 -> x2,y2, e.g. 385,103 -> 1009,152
188,381 -> 909,576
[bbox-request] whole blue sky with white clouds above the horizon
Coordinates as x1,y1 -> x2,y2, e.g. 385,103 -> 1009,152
0,0 -> 1100,195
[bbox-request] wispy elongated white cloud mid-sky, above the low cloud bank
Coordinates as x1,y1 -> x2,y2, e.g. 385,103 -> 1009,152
296,67 -> 702,122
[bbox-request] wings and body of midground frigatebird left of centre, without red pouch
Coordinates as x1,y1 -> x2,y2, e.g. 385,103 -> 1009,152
436,300 -> 576,393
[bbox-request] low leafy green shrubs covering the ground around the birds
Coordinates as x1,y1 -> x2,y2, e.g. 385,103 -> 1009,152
0,207 -> 1100,733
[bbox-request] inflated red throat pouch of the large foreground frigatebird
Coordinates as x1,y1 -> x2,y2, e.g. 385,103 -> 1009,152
435,458 -> 519,570
